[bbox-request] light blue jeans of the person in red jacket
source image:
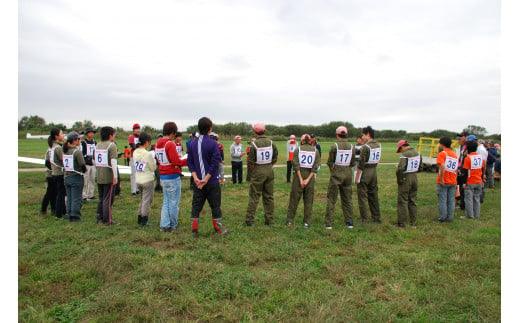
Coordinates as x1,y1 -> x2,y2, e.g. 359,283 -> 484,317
160,177 -> 181,228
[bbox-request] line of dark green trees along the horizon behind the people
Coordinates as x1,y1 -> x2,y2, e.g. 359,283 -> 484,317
18,116 -> 501,141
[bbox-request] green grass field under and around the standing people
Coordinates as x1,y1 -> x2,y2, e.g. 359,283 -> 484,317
18,139 -> 501,322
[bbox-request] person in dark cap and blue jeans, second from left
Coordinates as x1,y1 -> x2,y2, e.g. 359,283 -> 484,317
63,131 -> 87,222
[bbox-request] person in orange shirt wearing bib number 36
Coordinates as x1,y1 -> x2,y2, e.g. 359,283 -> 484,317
437,137 -> 459,223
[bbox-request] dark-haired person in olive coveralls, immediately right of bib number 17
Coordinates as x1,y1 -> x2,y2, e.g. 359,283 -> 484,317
355,126 -> 381,223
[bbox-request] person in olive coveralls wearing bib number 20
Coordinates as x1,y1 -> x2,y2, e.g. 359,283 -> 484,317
285,134 -> 321,228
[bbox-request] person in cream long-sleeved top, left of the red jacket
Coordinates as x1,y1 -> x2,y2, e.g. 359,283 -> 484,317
134,132 -> 157,227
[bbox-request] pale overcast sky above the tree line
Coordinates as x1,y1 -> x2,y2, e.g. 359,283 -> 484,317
18,0 -> 501,133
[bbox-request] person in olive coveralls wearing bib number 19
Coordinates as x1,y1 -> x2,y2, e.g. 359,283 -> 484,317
245,122 -> 278,226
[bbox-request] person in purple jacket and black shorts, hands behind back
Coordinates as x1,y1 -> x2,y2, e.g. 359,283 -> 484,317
188,117 -> 229,237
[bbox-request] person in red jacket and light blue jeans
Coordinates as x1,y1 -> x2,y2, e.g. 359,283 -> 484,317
155,121 -> 187,232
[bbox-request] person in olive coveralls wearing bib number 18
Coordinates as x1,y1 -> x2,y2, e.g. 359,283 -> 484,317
395,140 -> 421,228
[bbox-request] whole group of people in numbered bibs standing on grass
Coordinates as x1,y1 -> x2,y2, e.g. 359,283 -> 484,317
37,117 -> 500,236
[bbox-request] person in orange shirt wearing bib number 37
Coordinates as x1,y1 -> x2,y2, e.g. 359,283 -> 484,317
461,140 -> 486,219
